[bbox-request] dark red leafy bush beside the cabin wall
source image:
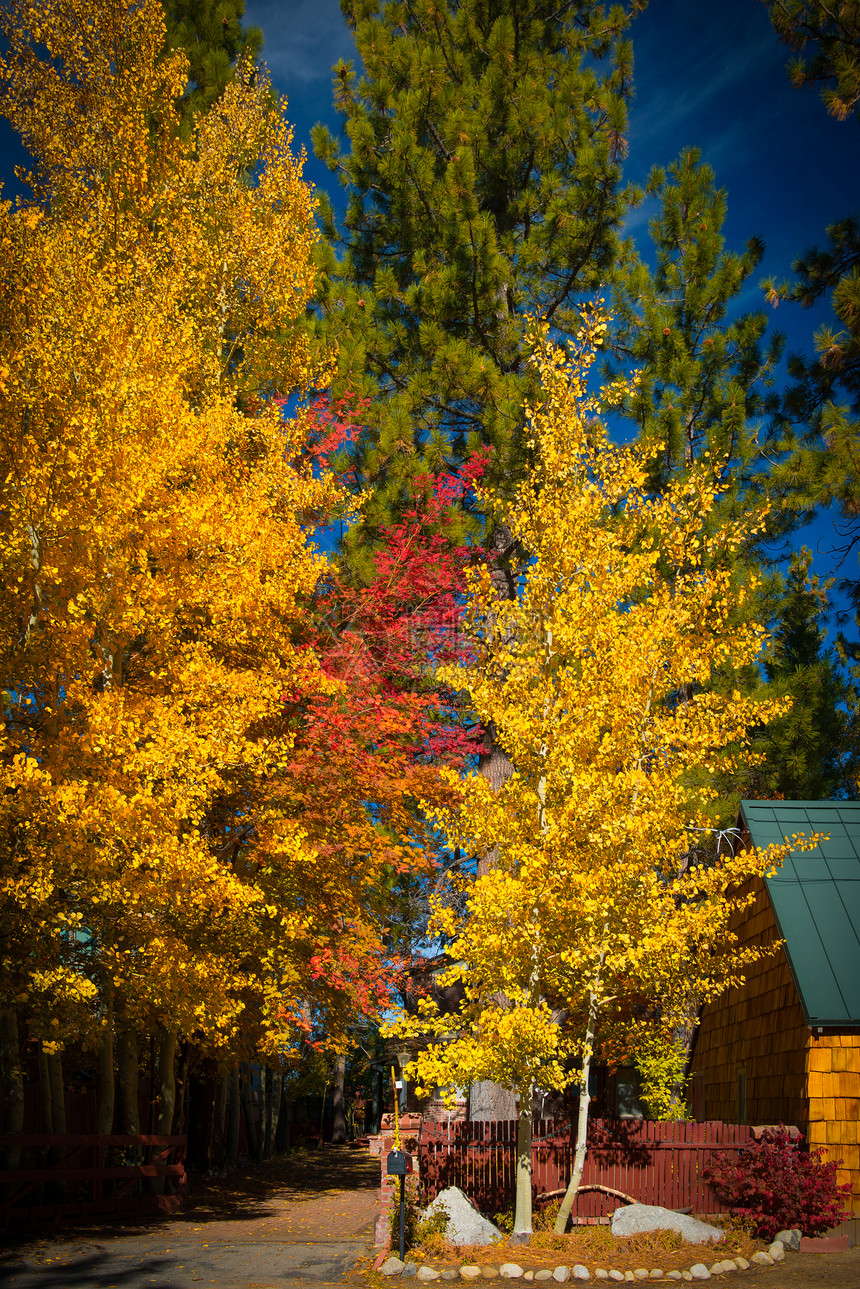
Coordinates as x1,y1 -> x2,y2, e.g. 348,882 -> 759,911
704,1124 -> 851,1240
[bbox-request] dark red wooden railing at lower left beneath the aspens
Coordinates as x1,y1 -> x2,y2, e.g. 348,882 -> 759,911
0,1133 -> 187,1226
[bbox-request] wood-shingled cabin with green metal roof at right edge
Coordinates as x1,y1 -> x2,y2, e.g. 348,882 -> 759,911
690,800 -> 860,1244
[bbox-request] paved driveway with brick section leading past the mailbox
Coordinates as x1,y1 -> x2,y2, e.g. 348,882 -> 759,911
0,1148 -> 379,1289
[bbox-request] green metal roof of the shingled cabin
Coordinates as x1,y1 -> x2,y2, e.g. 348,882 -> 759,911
740,800 -> 860,1029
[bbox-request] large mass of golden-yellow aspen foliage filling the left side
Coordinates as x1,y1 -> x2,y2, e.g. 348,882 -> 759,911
0,0 -> 407,1108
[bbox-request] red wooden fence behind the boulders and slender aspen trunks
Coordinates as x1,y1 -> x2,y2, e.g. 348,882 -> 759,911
418,1119 -> 752,1222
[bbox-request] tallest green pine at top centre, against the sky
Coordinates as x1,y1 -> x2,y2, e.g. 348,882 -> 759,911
313,0 -> 641,563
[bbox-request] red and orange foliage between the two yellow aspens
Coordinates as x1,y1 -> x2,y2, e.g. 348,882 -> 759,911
266,400 -> 484,1014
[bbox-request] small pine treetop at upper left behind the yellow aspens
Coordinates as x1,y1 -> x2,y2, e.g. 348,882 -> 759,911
162,0 -> 263,128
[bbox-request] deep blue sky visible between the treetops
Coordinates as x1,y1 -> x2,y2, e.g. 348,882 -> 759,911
0,0 -> 860,592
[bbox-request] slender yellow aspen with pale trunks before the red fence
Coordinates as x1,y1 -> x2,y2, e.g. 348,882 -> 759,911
396,309 -> 809,1240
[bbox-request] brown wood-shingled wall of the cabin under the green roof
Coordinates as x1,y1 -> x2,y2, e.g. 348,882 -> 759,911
690,878 -> 860,1217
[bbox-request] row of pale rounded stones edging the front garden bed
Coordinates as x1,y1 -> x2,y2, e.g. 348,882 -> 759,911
379,1231 -> 799,1284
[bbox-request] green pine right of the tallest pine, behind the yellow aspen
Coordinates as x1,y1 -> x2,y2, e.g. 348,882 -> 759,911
609,148 -> 783,533
